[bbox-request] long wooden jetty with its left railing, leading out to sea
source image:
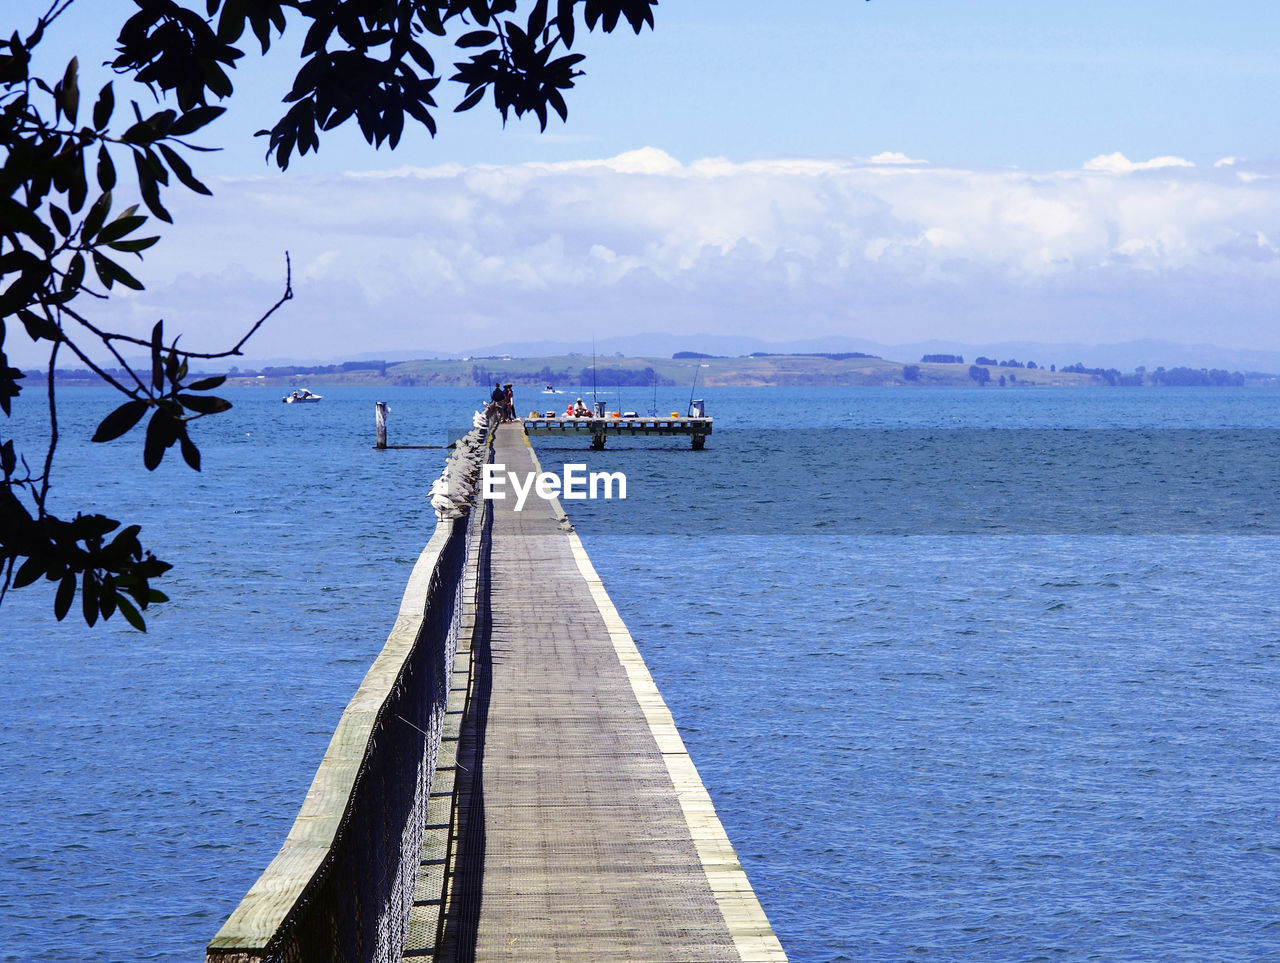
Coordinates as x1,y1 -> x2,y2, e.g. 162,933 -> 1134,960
207,424 -> 786,963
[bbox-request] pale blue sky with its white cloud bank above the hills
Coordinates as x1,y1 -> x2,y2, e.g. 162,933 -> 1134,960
4,0 -> 1280,361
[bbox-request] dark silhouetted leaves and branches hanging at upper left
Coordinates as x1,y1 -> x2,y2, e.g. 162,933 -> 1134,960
0,0 -> 657,629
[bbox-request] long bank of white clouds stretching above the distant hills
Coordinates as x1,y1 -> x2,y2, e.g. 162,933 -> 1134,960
20,149 -> 1280,357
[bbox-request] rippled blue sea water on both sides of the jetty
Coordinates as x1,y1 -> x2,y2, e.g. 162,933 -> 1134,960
0,388 -> 1280,960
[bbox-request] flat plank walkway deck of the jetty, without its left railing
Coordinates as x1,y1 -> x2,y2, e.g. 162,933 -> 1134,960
404,424 -> 786,963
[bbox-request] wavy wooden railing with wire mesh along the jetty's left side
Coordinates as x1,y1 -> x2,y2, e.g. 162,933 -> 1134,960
206,478 -> 484,963
